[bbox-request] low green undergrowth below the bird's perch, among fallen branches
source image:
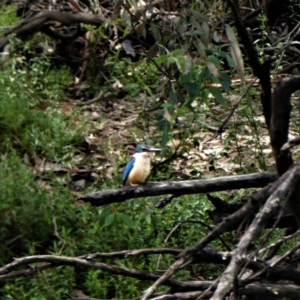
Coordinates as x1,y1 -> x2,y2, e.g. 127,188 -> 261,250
0,182 -> 220,299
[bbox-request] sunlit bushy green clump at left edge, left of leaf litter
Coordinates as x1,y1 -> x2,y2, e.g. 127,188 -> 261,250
0,47 -> 85,162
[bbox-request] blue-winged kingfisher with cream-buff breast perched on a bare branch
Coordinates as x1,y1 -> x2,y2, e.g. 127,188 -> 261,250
122,145 -> 162,185
